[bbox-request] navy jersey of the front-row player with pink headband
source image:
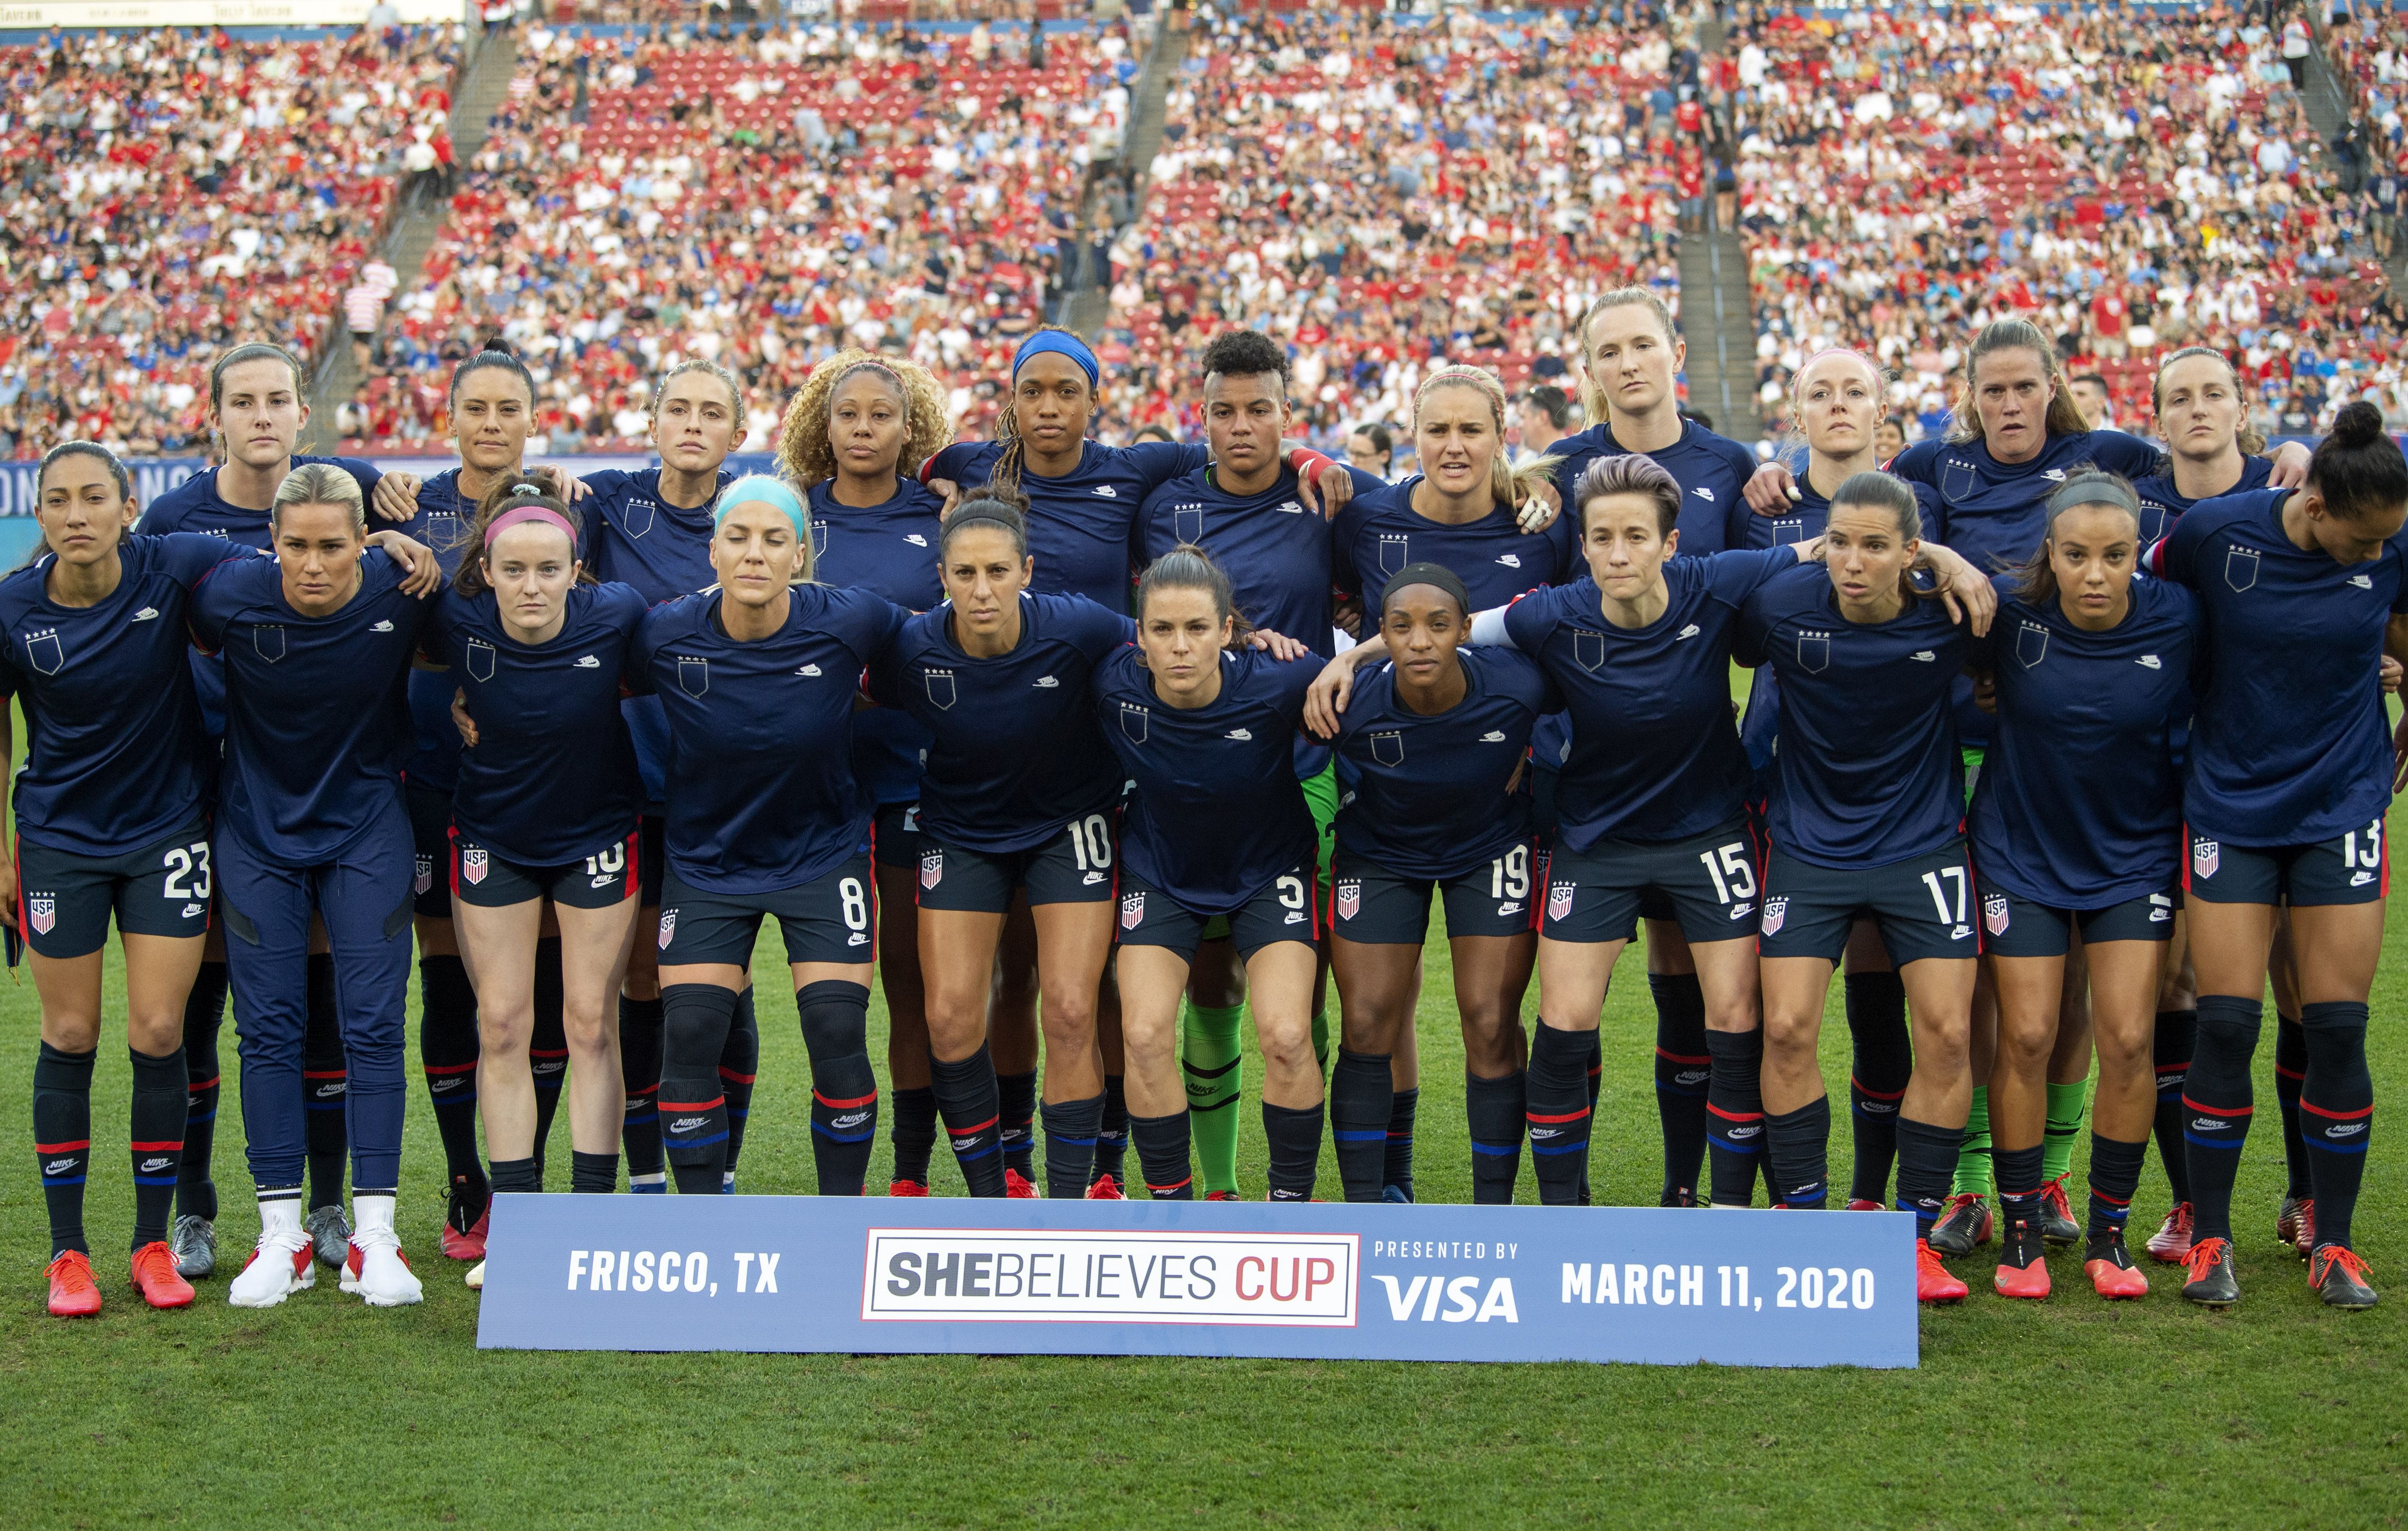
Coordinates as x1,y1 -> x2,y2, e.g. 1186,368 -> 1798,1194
419,585 -> 645,867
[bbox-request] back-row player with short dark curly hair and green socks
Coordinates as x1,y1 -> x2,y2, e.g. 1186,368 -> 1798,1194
1131,330 -> 1387,1201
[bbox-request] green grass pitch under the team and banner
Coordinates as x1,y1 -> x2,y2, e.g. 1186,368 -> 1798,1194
0,881 -> 2408,1526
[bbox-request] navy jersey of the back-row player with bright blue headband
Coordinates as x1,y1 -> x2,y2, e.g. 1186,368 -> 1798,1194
920,441 -> 1213,604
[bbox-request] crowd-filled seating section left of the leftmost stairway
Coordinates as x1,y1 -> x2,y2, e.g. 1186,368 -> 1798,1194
0,29 -> 457,457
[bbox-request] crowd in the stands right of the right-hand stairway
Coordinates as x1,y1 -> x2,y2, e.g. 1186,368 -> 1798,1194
1729,5 -> 2408,438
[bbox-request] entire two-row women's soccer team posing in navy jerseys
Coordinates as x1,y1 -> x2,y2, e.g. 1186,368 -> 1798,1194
18,289 -> 2408,1317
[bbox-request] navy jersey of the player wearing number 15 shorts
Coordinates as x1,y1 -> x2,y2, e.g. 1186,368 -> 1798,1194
1505,549 -> 1820,850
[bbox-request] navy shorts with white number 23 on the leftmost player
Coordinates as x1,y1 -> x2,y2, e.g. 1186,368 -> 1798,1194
17,818 -> 217,958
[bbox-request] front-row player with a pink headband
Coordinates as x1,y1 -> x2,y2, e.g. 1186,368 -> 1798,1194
422,474 -> 645,1285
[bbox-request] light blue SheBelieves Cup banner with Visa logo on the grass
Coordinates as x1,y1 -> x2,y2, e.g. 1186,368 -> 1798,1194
477,1194 -> 1917,1367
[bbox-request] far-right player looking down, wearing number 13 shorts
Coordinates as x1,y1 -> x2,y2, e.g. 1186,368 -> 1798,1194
2148,402 -> 2408,1307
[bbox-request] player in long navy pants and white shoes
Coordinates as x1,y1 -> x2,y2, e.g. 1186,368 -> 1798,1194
190,462 -> 447,1307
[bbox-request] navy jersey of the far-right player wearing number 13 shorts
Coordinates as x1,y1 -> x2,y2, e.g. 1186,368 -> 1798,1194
2148,489 -> 2408,845
